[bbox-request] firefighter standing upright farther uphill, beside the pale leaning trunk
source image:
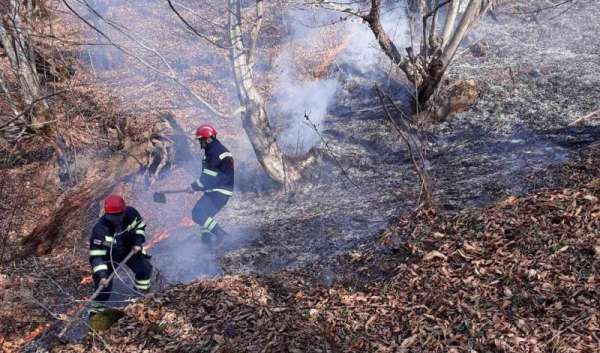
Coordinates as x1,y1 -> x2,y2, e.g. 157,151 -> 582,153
190,124 -> 234,246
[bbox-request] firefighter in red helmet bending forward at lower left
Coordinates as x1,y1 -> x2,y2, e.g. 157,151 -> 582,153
90,195 -> 152,314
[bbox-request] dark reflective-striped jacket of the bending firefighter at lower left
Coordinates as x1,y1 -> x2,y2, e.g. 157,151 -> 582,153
90,207 -> 146,278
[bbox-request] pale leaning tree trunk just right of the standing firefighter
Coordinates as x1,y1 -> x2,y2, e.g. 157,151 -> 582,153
228,0 -> 289,184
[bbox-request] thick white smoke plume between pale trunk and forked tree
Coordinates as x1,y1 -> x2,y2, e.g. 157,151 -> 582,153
269,8 -> 409,155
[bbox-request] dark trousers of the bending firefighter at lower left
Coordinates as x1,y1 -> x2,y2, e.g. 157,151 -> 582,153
91,253 -> 152,311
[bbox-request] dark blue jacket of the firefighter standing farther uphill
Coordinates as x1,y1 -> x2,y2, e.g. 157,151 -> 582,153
192,138 -> 234,196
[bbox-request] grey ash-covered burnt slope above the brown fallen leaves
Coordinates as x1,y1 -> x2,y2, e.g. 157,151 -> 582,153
203,1 -> 600,273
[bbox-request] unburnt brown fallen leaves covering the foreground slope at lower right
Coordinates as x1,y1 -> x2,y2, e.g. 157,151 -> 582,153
52,175 -> 600,352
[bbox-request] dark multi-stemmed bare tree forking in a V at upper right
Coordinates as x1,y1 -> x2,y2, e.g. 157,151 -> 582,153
308,0 -> 504,108
